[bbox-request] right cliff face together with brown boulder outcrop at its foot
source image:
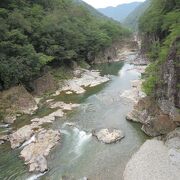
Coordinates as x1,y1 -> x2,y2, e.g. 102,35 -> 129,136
127,38 -> 180,136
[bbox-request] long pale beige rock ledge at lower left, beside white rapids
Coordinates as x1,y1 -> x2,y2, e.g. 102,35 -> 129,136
7,99 -> 79,172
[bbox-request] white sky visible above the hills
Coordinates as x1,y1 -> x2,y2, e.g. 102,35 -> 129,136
83,0 -> 144,8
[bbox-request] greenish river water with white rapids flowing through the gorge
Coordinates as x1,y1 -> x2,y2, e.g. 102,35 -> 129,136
0,57 -> 147,180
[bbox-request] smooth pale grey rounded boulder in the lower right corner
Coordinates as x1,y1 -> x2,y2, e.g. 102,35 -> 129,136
124,139 -> 180,180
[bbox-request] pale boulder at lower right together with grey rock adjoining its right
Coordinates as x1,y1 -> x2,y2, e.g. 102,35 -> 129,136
124,128 -> 180,180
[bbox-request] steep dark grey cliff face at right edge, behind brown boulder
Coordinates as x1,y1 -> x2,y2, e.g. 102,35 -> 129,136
156,37 -> 180,123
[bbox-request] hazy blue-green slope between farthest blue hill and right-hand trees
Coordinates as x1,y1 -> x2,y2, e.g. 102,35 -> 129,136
123,0 -> 151,31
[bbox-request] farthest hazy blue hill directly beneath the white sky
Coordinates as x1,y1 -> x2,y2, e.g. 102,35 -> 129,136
97,2 -> 142,22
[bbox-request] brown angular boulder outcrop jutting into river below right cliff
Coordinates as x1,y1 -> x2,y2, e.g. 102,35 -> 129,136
126,97 -> 177,136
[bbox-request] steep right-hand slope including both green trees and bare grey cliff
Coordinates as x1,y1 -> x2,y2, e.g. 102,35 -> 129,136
139,0 -> 180,107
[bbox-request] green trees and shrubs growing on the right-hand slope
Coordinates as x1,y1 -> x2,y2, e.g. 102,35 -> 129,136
139,0 -> 180,95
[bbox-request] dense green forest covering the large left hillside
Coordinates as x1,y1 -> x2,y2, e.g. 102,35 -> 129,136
0,0 -> 128,89
